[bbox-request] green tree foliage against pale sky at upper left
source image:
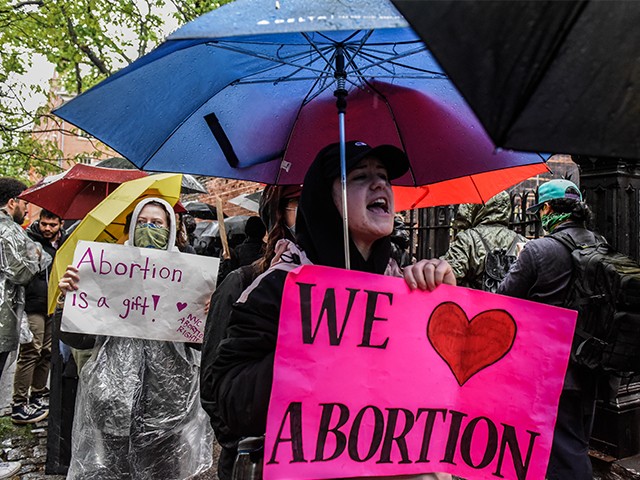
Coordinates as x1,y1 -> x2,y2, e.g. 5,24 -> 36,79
0,0 -> 229,177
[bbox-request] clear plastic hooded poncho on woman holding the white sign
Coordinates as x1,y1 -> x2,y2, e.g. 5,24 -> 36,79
67,198 -> 213,480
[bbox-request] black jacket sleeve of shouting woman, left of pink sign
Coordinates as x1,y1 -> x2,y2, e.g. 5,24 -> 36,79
200,270 -> 287,480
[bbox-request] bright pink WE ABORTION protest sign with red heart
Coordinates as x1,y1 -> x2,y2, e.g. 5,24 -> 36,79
264,266 -> 576,480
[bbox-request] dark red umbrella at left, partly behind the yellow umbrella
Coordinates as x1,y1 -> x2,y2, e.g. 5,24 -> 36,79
19,163 -> 148,220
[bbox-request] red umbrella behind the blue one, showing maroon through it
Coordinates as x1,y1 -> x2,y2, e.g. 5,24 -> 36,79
278,81 -> 548,211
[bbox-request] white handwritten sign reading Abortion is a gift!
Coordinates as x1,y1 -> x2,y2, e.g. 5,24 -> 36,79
61,241 -> 220,343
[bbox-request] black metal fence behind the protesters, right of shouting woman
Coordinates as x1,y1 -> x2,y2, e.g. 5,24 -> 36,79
405,190 -> 541,260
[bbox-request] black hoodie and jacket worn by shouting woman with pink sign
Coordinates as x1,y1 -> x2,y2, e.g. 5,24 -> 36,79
200,142 -> 406,480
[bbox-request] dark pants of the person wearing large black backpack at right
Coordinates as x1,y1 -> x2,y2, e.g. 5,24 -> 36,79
547,382 -> 596,480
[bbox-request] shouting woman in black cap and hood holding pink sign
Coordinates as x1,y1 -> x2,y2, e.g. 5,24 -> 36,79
202,142 -> 455,478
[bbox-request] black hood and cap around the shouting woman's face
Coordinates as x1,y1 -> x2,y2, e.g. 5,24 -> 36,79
296,142 -> 408,274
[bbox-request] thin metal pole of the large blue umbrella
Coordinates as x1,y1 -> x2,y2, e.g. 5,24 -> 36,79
333,48 -> 351,270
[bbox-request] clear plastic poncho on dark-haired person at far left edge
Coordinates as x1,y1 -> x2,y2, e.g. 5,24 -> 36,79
0,210 -> 51,352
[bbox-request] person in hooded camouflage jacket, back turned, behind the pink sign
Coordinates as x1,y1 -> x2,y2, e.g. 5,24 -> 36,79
442,192 -> 527,290
